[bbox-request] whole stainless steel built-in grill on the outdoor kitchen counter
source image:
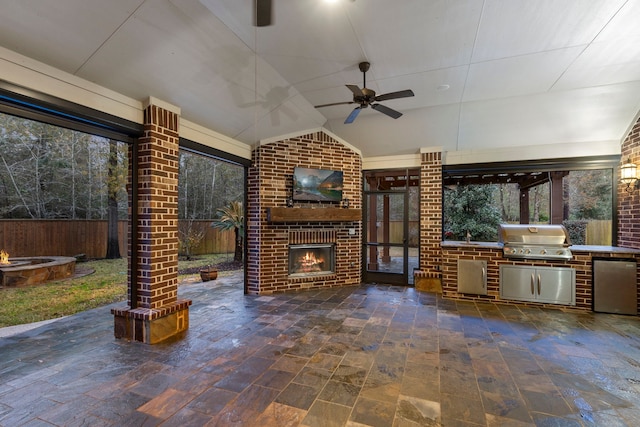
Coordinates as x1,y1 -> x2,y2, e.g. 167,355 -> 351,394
498,224 -> 573,260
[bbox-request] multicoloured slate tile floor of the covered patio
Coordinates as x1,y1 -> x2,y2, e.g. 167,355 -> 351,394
0,274 -> 640,427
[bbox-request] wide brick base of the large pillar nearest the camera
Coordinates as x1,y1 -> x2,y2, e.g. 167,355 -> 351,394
111,300 -> 191,344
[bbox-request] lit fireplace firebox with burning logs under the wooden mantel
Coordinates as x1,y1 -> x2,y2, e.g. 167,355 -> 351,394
289,243 -> 336,277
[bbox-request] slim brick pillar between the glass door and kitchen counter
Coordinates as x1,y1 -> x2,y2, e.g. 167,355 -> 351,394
414,152 -> 442,292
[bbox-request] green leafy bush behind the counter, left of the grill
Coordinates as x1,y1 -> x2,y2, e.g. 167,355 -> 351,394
443,185 -> 501,242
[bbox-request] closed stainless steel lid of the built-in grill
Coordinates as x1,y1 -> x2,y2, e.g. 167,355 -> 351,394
498,224 -> 571,247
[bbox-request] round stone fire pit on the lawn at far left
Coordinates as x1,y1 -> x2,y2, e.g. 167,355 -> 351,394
0,256 -> 76,286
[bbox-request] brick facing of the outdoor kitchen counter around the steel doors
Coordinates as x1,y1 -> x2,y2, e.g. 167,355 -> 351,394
442,247 -> 640,310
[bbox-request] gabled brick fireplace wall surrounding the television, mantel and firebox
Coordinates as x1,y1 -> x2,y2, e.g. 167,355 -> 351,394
247,132 -> 362,294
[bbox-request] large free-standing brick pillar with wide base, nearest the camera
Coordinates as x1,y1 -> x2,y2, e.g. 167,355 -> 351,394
111,99 -> 191,344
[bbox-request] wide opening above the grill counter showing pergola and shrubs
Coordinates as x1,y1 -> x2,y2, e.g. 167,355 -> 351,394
443,156 -> 619,245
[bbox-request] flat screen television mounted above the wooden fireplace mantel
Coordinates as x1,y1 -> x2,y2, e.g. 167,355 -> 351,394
292,167 -> 343,202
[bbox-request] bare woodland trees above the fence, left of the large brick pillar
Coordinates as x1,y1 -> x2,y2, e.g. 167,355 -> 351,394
0,113 -> 127,219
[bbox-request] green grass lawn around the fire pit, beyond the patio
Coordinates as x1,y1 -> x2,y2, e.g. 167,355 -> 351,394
0,254 -> 238,327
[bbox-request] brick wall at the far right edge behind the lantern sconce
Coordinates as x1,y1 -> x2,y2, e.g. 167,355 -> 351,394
618,119 -> 640,249
